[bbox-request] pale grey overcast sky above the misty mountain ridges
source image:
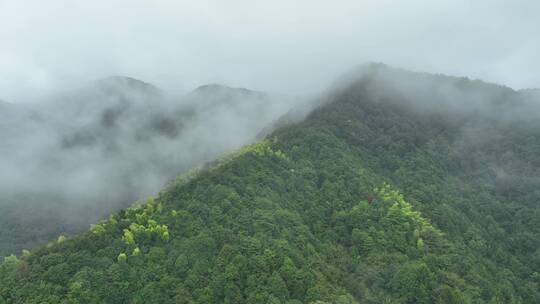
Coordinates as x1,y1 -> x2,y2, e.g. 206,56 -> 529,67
0,0 -> 540,102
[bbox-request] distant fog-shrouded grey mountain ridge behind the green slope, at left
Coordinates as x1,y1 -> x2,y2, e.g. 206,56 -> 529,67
0,77 -> 296,256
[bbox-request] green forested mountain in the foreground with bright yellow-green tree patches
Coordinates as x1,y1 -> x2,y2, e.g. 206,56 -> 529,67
0,64 -> 540,304
